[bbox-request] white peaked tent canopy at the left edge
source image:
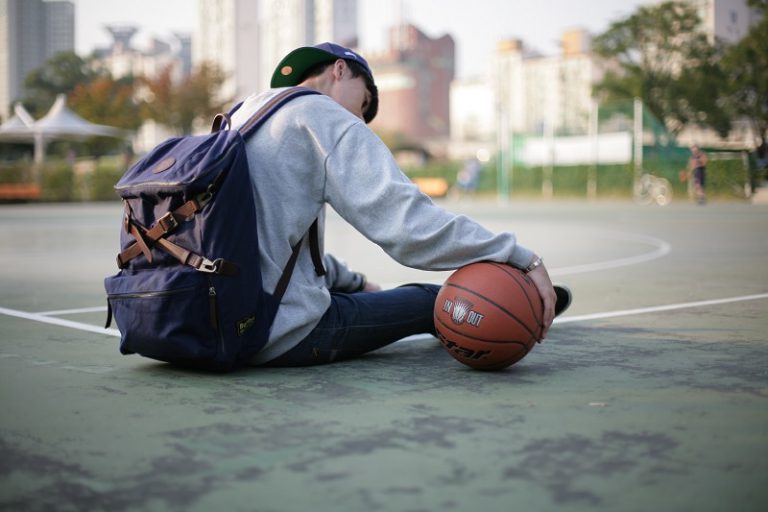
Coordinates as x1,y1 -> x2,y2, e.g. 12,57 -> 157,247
0,94 -> 130,163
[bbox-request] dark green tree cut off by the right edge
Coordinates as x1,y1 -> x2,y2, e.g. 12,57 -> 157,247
723,1 -> 768,147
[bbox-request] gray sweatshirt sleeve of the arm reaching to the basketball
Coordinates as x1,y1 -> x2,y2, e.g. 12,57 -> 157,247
325,122 -> 533,270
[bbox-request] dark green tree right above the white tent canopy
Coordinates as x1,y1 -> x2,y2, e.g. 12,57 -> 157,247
22,52 -> 99,117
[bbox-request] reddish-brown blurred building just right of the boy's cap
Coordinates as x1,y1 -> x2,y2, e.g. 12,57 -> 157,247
367,24 -> 456,150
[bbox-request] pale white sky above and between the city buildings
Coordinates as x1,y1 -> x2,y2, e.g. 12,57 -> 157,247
73,0 -> 652,78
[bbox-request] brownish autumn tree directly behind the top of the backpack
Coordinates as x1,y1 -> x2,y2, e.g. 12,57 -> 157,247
143,64 -> 229,134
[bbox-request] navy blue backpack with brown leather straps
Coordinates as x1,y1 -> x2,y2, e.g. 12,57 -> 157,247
104,87 -> 324,371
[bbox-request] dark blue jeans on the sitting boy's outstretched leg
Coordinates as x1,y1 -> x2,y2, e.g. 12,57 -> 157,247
264,284 -> 440,367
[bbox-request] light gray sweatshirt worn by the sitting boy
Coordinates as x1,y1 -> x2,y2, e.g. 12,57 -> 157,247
233,89 -> 533,364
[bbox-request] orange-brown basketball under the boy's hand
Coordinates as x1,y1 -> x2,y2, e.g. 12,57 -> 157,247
434,262 -> 543,370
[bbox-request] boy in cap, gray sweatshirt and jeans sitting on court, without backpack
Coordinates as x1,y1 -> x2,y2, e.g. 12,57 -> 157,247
232,43 -> 570,366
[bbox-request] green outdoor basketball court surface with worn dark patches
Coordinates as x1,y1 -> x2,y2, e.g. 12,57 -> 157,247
0,201 -> 768,512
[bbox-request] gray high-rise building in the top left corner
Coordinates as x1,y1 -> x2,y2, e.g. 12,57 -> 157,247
0,0 -> 75,119
